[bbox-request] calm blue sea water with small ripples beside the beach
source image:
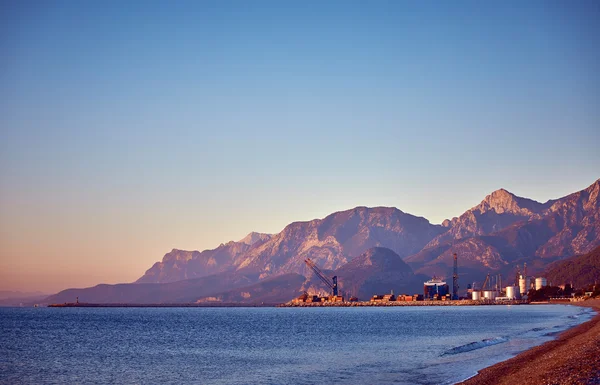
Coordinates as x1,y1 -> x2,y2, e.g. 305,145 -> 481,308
0,305 -> 592,385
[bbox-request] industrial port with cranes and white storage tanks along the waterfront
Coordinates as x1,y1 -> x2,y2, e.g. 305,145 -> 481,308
280,253 -> 547,307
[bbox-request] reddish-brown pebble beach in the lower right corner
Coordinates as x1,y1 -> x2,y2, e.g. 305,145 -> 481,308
457,299 -> 600,385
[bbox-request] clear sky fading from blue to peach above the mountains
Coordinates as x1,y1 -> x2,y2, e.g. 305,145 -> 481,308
0,0 -> 600,293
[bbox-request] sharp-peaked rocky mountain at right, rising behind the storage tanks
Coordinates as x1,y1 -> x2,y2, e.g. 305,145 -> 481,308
406,180 -> 600,284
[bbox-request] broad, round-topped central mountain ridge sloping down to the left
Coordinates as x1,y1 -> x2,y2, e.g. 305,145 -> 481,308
137,207 -> 445,283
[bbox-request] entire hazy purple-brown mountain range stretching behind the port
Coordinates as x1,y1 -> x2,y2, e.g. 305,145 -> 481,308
46,179 -> 600,303
